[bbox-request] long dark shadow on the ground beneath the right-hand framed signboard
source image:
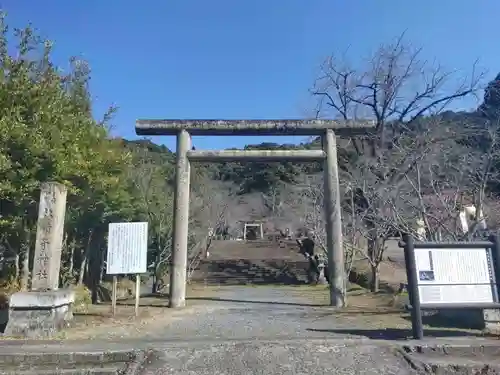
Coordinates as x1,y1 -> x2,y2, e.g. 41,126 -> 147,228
307,328 -> 489,340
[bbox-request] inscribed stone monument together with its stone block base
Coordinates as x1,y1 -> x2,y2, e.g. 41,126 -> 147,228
5,183 -> 74,337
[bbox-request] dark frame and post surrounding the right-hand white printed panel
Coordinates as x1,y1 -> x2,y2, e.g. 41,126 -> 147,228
400,236 -> 500,339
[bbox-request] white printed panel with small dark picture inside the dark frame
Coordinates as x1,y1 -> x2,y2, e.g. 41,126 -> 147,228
414,248 -> 494,305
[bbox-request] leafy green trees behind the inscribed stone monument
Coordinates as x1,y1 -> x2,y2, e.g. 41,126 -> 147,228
0,14 -> 136,288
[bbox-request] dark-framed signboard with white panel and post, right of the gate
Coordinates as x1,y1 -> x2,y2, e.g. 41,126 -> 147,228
401,236 -> 500,339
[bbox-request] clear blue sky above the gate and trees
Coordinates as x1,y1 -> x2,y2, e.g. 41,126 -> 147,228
2,0 -> 500,149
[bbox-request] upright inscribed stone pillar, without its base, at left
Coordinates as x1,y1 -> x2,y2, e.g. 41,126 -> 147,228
31,182 -> 67,290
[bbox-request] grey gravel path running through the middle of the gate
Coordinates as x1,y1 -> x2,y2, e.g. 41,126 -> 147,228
139,287 -> 376,340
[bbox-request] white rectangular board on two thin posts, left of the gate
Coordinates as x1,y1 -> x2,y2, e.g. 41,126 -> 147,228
106,223 -> 148,275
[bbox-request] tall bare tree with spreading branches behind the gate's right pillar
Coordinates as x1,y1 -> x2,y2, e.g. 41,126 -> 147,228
312,35 -> 482,291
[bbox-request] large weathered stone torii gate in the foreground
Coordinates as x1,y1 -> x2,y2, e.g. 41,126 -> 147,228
135,120 -> 374,308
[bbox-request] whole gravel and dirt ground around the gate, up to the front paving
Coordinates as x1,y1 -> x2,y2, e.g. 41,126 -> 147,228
80,286 -> 480,342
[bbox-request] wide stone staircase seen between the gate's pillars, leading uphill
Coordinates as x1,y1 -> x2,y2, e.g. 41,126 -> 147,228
191,241 -> 308,285
